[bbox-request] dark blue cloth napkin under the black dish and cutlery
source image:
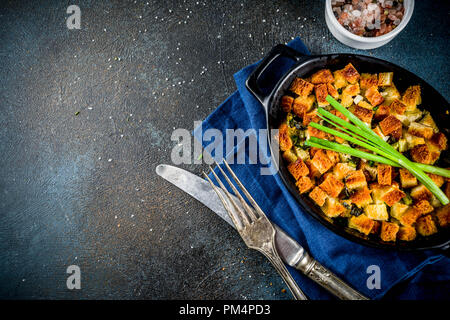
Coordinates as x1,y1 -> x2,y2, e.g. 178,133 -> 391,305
194,38 -> 450,299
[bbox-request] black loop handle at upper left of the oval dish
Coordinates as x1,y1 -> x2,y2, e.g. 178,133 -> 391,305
245,44 -> 308,110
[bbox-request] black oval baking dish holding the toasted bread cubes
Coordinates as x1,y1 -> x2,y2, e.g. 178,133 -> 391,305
246,45 -> 450,254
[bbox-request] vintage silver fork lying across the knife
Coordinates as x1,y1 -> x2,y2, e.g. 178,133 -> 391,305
203,160 -> 308,300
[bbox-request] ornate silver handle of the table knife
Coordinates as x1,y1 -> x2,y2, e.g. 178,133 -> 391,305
295,252 -> 369,300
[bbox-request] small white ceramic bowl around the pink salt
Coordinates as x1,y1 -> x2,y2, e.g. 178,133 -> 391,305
325,0 -> 414,50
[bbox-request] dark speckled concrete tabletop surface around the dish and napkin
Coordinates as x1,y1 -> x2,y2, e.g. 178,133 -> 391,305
0,0 -> 450,299
